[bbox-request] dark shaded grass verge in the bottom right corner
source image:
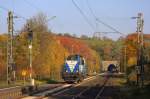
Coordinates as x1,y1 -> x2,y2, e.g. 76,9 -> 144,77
108,78 -> 150,99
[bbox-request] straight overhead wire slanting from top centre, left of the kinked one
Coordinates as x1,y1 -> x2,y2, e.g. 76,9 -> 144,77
72,0 -> 95,30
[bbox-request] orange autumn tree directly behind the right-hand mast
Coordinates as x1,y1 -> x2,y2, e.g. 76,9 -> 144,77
125,33 -> 150,81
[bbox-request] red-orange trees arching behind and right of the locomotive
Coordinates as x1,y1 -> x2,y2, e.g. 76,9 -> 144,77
57,36 -> 100,74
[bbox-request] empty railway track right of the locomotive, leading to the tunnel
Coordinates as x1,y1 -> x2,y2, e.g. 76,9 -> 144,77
49,76 -> 109,99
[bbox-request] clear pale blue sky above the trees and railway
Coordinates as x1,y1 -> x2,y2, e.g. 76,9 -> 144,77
0,0 -> 150,38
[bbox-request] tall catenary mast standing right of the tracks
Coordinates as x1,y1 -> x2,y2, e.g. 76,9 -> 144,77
132,13 -> 144,87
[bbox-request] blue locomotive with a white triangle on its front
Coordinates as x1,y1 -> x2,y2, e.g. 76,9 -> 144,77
62,55 -> 87,83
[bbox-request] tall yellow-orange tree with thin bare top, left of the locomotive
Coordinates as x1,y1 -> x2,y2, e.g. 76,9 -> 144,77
16,13 -> 67,80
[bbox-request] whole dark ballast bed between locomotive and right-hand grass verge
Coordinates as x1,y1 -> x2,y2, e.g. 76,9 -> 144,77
23,73 -> 120,99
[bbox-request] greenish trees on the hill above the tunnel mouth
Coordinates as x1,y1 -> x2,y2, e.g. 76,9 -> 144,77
84,37 -> 123,61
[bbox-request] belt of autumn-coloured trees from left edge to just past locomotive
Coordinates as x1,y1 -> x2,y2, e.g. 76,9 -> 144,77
0,32 -> 100,80
